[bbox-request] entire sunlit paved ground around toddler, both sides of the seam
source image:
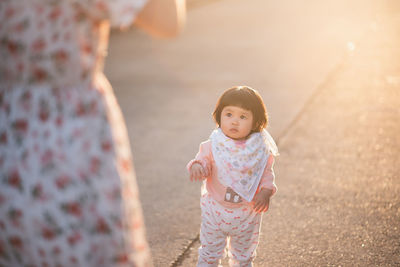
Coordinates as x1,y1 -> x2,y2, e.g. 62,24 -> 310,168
106,0 -> 400,267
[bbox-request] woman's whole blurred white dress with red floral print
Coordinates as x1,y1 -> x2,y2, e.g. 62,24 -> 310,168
0,0 -> 151,267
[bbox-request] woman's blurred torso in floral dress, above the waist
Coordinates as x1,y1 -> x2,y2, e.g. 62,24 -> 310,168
0,0 -> 108,90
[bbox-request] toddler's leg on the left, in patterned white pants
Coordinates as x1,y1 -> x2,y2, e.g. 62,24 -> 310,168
197,196 -> 227,267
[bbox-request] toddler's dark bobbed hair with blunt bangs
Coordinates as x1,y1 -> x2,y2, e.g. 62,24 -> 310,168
213,86 -> 268,132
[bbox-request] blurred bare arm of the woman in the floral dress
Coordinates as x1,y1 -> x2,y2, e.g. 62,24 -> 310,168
135,0 -> 186,37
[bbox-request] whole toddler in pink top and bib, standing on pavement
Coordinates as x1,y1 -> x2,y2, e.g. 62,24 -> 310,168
187,86 -> 278,267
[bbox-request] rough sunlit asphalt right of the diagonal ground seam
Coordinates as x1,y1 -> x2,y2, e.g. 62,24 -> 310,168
177,4 -> 400,266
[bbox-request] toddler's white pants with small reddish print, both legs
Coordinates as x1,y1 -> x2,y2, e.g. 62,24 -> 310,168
197,194 -> 262,267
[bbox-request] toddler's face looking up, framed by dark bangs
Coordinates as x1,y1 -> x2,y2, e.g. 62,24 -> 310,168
220,106 -> 253,140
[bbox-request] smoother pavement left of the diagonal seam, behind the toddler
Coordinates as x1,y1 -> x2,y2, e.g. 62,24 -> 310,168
106,0 -> 396,266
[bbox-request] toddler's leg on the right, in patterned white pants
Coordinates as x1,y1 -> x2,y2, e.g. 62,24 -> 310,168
229,213 -> 261,267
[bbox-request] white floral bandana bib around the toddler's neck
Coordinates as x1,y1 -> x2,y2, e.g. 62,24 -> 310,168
210,128 -> 278,202
